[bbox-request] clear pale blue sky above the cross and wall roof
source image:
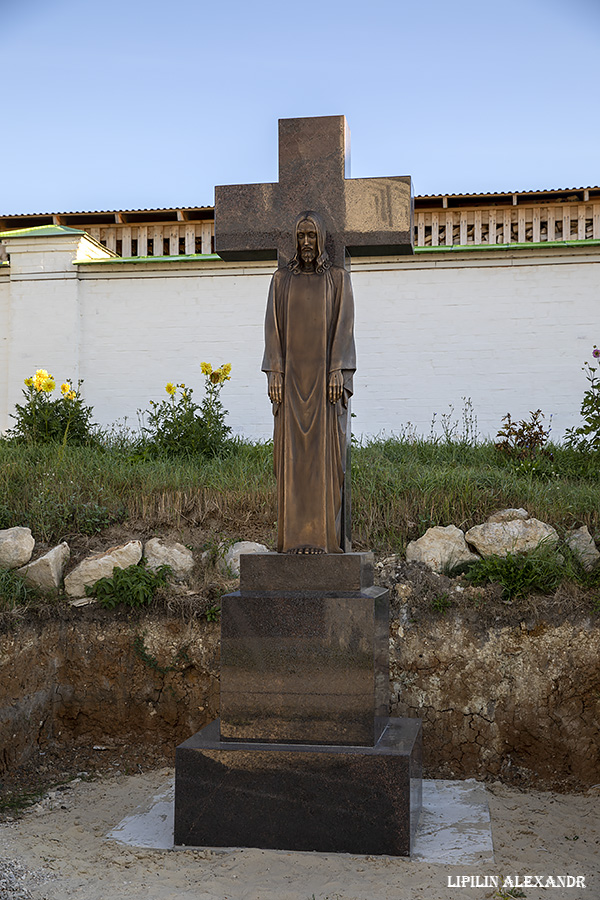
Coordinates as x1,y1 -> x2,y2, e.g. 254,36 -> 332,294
0,0 -> 600,214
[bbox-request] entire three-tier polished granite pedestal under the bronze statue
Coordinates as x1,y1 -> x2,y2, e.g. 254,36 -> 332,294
175,553 -> 422,856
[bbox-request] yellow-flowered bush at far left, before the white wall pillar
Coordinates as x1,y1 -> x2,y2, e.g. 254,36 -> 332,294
6,369 -> 95,445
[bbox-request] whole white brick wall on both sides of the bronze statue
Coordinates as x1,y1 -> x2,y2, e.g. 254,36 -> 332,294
0,239 -> 600,437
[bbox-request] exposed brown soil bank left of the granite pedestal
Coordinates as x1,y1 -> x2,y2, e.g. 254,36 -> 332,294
0,607 -> 219,774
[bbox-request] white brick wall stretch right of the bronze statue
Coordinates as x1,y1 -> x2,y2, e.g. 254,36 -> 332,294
353,251 -> 600,437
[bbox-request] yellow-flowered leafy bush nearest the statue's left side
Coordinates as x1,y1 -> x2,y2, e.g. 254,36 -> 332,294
143,362 -> 231,456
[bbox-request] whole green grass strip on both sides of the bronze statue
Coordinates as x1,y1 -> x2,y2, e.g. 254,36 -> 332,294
0,439 -> 600,552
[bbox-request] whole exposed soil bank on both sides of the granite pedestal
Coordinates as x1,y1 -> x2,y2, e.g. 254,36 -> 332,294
0,596 -> 600,790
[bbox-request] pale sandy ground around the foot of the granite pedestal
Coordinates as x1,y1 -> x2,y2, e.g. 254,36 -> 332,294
0,769 -> 600,900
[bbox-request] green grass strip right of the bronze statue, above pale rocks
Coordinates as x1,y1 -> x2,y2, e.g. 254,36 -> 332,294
352,440 -> 600,550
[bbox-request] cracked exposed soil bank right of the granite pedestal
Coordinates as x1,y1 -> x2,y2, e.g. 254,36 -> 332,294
390,614 -> 600,790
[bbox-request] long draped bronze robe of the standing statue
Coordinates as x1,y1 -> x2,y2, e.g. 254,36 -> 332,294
262,266 -> 356,553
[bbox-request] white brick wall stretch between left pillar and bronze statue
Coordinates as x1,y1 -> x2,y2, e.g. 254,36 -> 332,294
80,264 -> 272,436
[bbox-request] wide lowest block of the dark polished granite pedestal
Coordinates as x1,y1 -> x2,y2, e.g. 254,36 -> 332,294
175,719 -> 422,856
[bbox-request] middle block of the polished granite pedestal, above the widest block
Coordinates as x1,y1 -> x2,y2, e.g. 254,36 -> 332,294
221,588 -> 389,746
